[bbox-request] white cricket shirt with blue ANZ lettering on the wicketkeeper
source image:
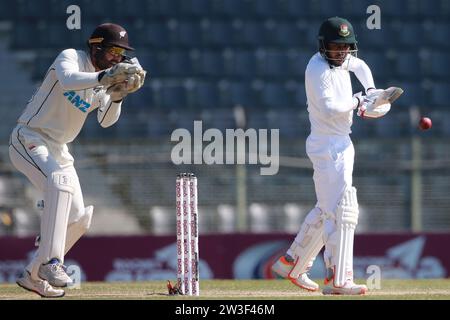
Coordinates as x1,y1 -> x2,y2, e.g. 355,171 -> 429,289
18,49 -> 121,144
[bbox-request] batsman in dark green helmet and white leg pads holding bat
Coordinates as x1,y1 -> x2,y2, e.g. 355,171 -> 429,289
272,17 -> 403,295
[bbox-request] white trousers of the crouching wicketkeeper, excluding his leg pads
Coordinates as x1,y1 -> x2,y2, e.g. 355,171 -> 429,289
9,124 -> 84,264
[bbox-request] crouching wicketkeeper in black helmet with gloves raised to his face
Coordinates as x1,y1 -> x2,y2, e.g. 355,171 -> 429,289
9,23 -> 146,297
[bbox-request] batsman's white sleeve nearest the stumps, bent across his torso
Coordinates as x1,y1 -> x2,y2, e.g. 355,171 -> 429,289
306,71 -> 359,118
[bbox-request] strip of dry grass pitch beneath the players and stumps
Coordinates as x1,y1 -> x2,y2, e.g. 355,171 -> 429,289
0,279 -> 450,300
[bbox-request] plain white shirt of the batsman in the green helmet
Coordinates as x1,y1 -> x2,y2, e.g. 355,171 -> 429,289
305,53 -> 375,135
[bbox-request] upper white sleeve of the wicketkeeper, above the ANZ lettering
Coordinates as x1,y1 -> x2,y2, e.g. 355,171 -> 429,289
54,49 -> 99,91
